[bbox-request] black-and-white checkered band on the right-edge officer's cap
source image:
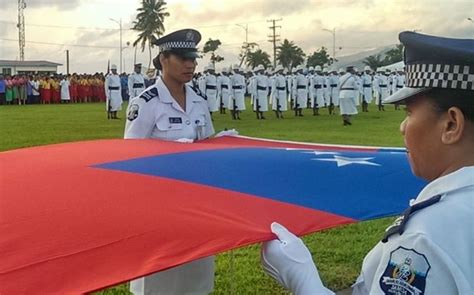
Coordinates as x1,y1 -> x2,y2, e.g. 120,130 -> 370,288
406,64 -> 474,90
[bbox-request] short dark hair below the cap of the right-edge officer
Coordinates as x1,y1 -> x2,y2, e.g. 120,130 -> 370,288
425,88 -> 474,123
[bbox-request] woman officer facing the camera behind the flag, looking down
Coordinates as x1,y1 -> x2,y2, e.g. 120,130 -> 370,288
124,29 -> 214,295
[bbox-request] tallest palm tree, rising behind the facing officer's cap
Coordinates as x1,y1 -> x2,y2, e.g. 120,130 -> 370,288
132,0 -> 170,67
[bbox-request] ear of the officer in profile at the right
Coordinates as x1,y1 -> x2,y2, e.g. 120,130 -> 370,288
441,107 -> 466,144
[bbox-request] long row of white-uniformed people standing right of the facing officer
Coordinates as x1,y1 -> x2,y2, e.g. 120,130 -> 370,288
194,65 -> 405,119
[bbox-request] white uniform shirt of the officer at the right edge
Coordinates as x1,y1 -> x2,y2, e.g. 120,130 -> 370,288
353,166 -> 474,295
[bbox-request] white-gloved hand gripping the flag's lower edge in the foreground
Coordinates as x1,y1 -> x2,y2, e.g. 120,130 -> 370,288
261,222 -> 334,295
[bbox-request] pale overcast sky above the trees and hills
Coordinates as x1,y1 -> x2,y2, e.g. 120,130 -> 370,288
0,0 -> 474,73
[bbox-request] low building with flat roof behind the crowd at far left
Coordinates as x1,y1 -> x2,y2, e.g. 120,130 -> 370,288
0,60 -> 62,75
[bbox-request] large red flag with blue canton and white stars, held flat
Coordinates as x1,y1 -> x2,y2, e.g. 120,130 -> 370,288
0,137 -> 424,294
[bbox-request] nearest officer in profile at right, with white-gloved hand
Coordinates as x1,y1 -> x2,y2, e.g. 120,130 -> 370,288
262,32 -> 474,295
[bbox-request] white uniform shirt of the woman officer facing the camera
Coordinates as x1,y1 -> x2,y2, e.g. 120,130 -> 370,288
124,77 -> 214,140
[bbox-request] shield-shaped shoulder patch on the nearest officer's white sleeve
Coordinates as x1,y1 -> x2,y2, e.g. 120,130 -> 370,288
379,247 -> 431,295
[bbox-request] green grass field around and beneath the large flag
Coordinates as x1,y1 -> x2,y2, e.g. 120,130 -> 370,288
0,103 -> 405,294
